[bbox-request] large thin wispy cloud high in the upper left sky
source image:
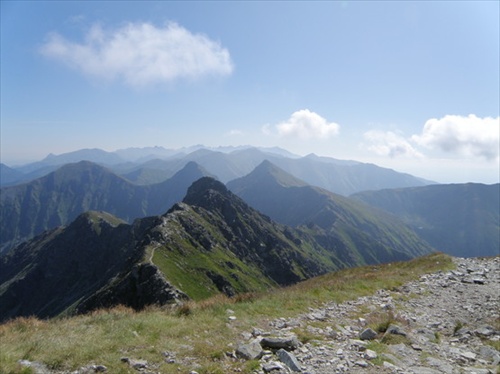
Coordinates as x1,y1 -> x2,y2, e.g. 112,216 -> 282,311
40,23 -> 233,86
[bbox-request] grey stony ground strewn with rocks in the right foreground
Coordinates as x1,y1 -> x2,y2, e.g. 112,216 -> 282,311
17,257 -> 500,374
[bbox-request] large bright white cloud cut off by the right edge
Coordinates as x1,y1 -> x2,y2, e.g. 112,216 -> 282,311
412,114 -> 500,160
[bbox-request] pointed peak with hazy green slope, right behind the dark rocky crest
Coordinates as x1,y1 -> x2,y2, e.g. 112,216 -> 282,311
228,162 -> 432,264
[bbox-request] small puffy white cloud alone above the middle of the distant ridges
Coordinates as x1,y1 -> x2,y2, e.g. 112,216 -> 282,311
270,109 -> 340,139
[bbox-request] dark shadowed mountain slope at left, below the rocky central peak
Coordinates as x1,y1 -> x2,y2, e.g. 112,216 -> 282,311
0,212 -> 170,319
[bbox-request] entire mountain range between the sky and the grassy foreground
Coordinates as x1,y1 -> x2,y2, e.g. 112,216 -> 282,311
0,146 -> 500,321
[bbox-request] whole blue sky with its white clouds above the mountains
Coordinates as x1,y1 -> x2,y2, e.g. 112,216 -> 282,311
0,1 -> 500,183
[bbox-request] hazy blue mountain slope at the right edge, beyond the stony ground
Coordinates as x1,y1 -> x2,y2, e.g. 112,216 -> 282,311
353,183 -> 500,257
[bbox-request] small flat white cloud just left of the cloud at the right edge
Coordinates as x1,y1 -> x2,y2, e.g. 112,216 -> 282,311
363,130 -> 423,158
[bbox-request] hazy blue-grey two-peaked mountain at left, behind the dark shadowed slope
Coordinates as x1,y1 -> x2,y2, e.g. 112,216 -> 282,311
0,161 -> 207,249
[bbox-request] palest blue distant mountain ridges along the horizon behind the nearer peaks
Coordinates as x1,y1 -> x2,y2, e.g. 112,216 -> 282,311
0,145 -> 434,196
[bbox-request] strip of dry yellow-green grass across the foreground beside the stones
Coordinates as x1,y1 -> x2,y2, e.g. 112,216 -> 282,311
0,253 -> 453,374
